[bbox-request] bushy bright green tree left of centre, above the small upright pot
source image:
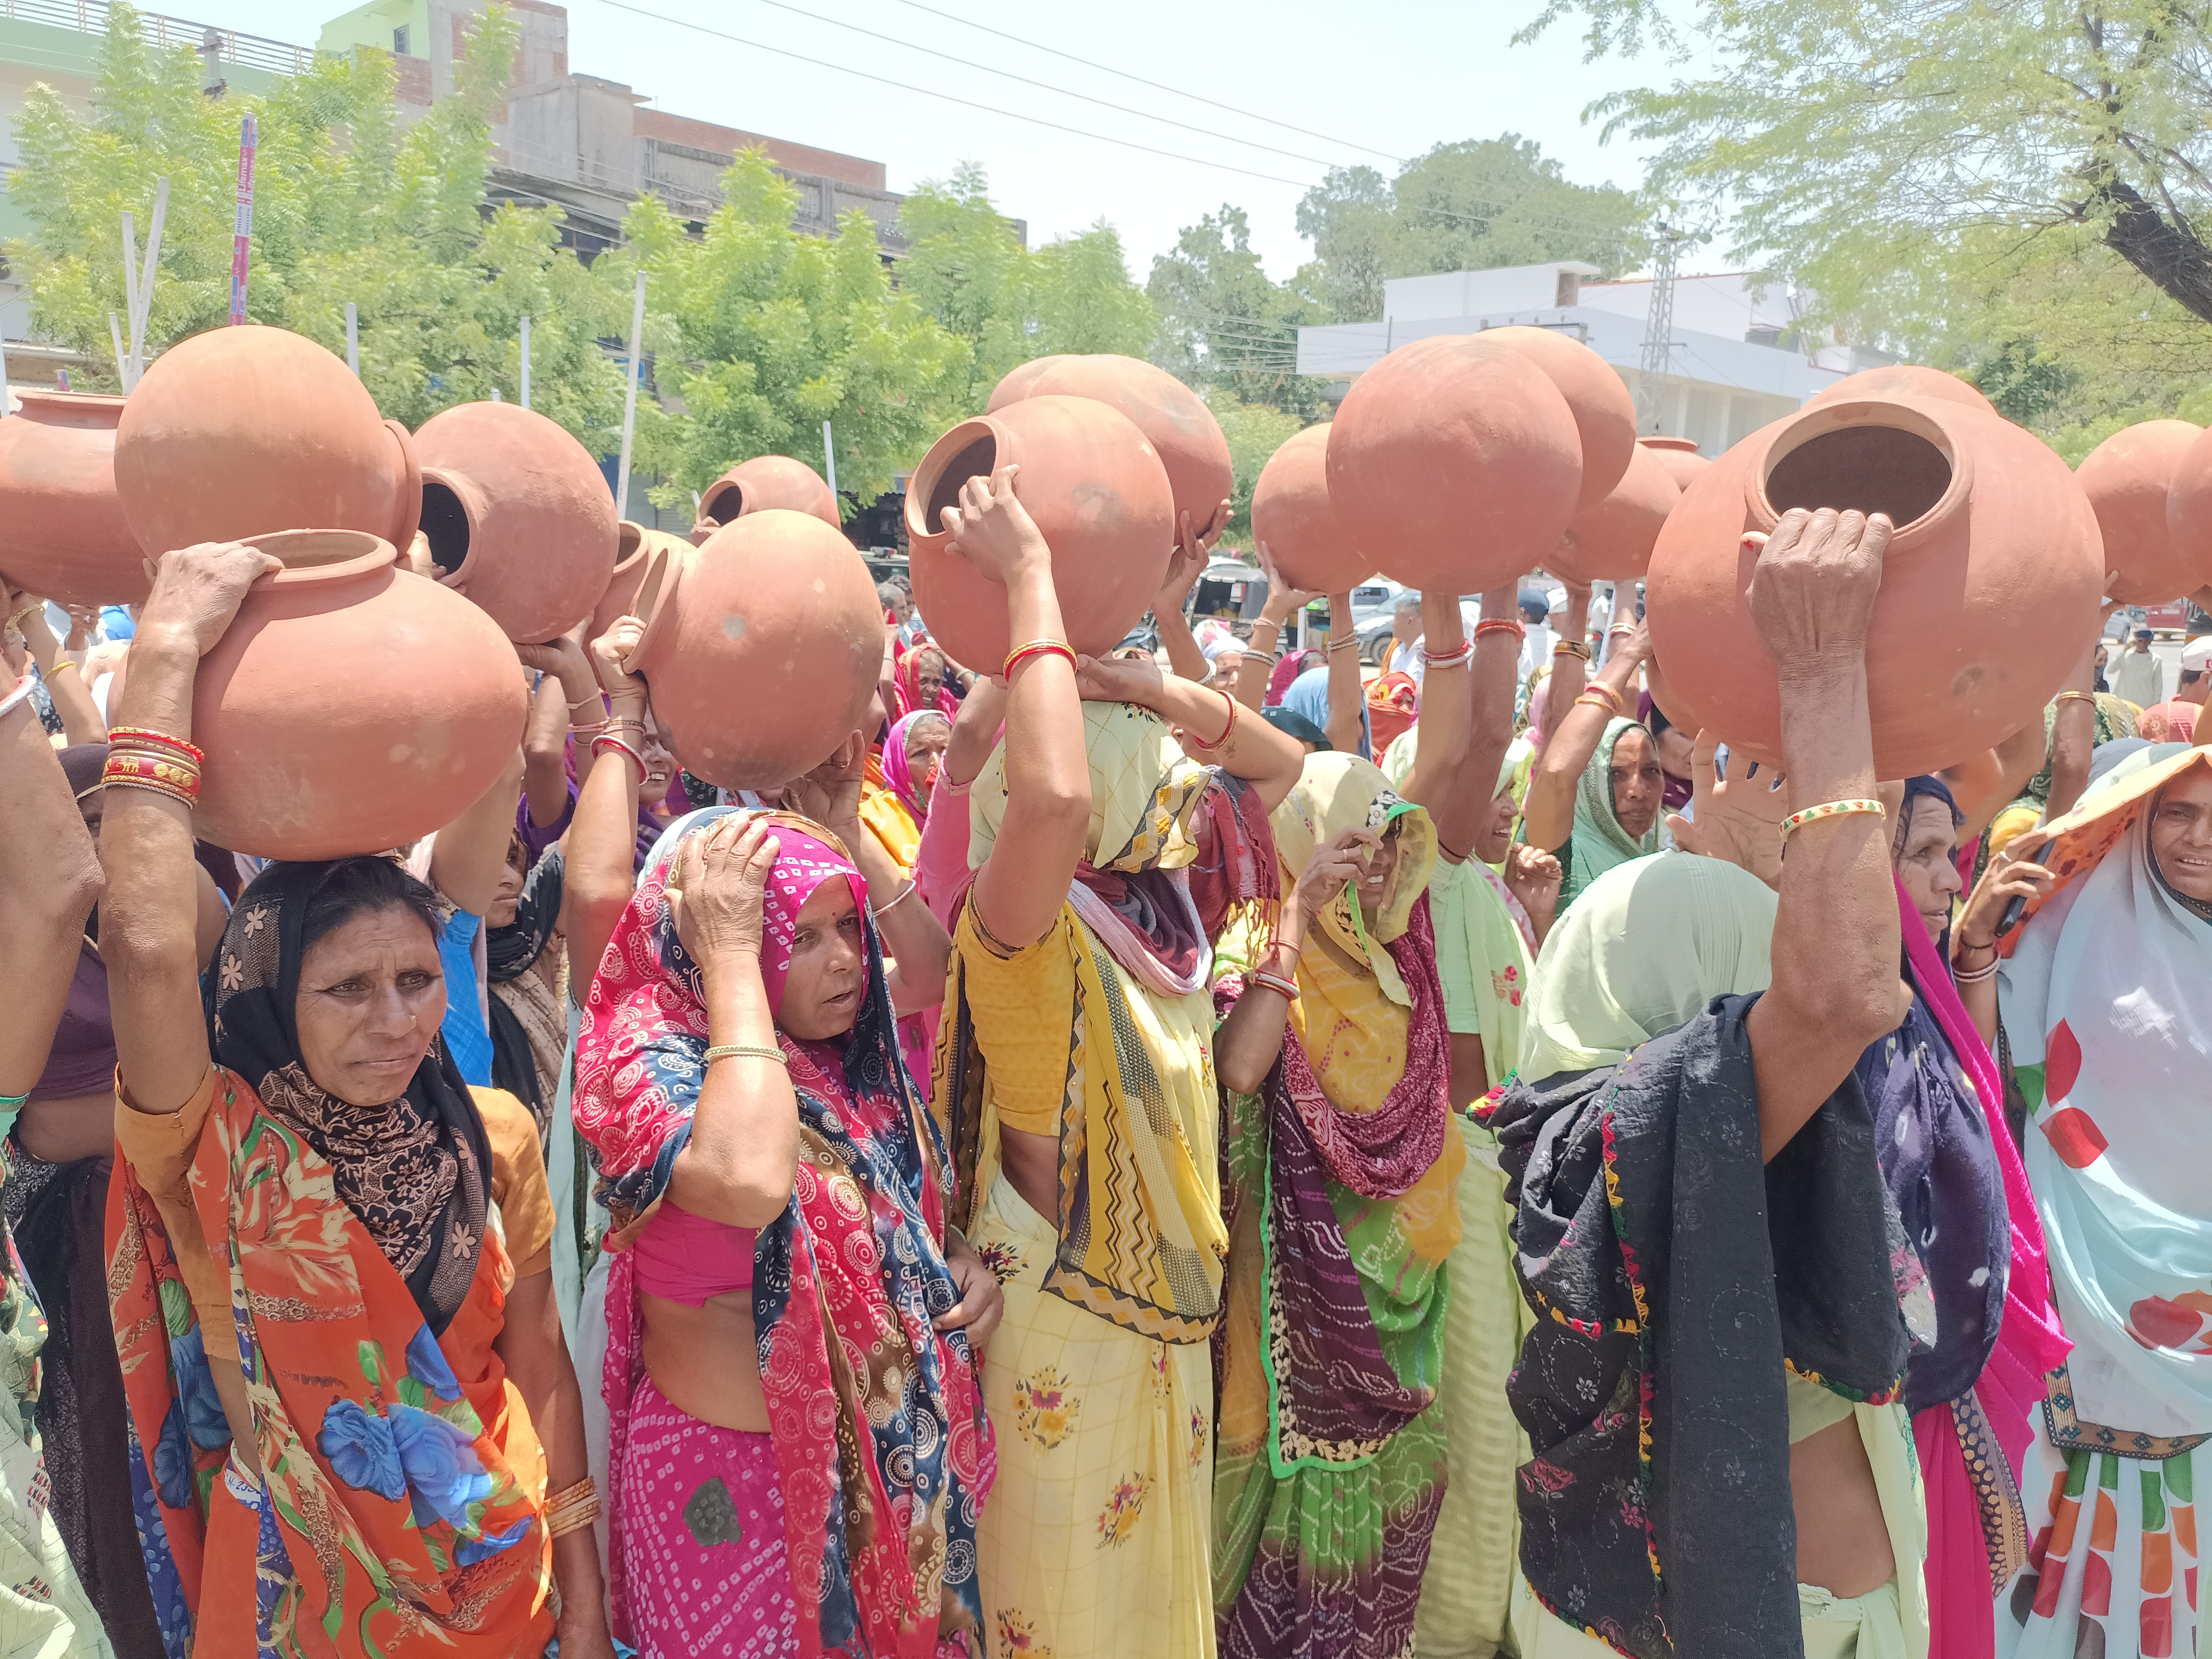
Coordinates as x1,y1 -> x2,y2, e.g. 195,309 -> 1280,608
624,150 -> 975,506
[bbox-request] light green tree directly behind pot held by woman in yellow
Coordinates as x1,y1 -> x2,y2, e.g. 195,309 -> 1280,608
898,161 -> 1159,409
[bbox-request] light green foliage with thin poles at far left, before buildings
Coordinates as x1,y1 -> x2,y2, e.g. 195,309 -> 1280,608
9,4 -> 626,454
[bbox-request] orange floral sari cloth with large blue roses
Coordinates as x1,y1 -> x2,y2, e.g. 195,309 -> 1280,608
106,1070 -> 553,1659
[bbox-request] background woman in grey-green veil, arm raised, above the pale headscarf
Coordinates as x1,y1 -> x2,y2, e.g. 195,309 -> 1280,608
1522,624 -> 1666,916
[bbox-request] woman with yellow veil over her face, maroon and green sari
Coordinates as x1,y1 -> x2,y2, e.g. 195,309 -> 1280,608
1214,754 -> 1467,1659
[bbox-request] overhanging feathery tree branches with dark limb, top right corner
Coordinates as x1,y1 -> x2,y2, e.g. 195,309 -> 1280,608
1528,0 -> 2212,451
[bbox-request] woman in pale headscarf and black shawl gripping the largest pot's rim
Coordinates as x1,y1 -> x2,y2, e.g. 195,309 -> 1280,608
1489,509 -> 1949,1659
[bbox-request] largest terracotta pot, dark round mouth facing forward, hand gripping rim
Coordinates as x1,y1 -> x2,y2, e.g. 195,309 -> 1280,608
1644,398 -> 2104,779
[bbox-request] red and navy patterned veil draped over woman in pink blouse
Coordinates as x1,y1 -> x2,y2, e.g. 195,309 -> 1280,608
575,810 -> 998,1659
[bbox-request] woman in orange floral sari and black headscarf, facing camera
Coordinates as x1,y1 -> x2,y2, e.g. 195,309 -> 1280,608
99,542 -> 613,1659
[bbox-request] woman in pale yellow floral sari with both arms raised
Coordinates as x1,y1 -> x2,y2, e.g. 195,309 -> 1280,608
931,469 -> 1298,1659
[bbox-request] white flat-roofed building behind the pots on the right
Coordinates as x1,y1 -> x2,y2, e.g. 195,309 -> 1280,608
1298,261 -> 1889,456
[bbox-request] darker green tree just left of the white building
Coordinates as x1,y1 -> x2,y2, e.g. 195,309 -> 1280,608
1146,204 -> 1329,425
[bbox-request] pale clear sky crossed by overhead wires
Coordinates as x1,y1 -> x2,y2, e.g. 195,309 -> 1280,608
211,0 -> 1670,296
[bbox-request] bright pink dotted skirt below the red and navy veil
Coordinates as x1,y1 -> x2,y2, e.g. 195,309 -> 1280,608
613,1378 -> 798,1659
